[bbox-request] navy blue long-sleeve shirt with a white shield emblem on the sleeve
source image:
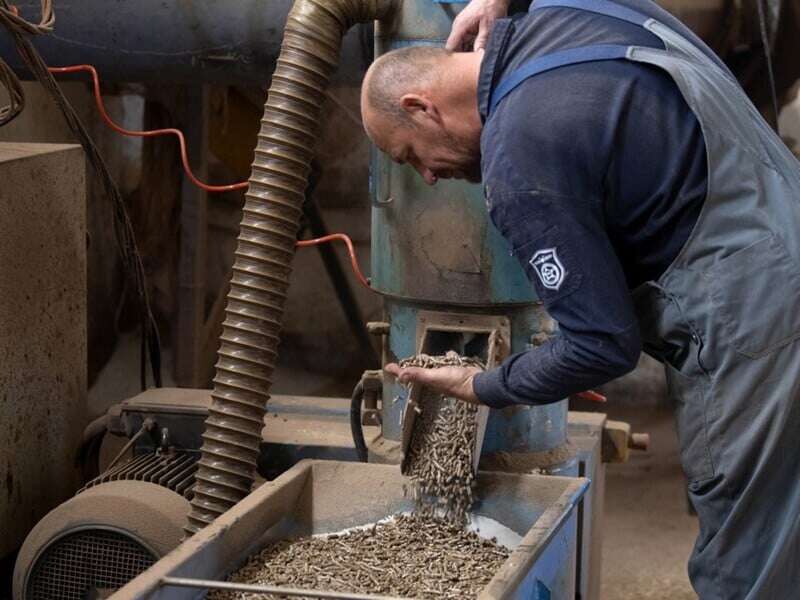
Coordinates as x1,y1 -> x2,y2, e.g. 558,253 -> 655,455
474,0 -> 718,408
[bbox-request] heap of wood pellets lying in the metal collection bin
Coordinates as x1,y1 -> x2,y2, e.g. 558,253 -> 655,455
208,515 -> 509,600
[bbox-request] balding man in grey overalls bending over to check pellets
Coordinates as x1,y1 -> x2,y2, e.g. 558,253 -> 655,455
362,0 -> 800,600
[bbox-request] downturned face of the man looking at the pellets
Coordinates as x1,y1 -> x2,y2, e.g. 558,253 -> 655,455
366,109 -> 481,185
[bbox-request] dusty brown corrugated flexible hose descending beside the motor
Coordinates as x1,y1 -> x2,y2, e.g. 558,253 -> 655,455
185,0 -> 392,535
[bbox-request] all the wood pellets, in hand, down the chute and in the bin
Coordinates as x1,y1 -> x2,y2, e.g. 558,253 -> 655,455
208,352 -> 509,600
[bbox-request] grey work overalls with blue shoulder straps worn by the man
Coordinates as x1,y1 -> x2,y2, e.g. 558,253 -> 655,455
490,0 -> 800,600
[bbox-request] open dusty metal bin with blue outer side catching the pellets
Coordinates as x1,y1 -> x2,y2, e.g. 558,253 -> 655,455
112,460 -> 589,600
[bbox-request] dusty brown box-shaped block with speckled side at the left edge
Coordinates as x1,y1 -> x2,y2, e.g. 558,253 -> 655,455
0,143 -> 86,556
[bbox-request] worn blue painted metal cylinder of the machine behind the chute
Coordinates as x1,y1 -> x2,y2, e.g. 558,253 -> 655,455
371,0 -> 567,453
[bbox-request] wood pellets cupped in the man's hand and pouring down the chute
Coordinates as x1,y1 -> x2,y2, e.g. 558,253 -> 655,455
400,352 -> 483,525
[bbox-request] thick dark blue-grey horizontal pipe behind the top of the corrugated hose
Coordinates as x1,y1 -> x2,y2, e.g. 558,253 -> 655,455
0,0 -> 369,85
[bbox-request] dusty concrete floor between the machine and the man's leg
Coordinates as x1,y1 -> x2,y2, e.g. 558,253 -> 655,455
602,405 -> 698,600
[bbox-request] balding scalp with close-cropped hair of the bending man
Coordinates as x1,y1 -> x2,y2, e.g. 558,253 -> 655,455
362,46 -> 451,126
